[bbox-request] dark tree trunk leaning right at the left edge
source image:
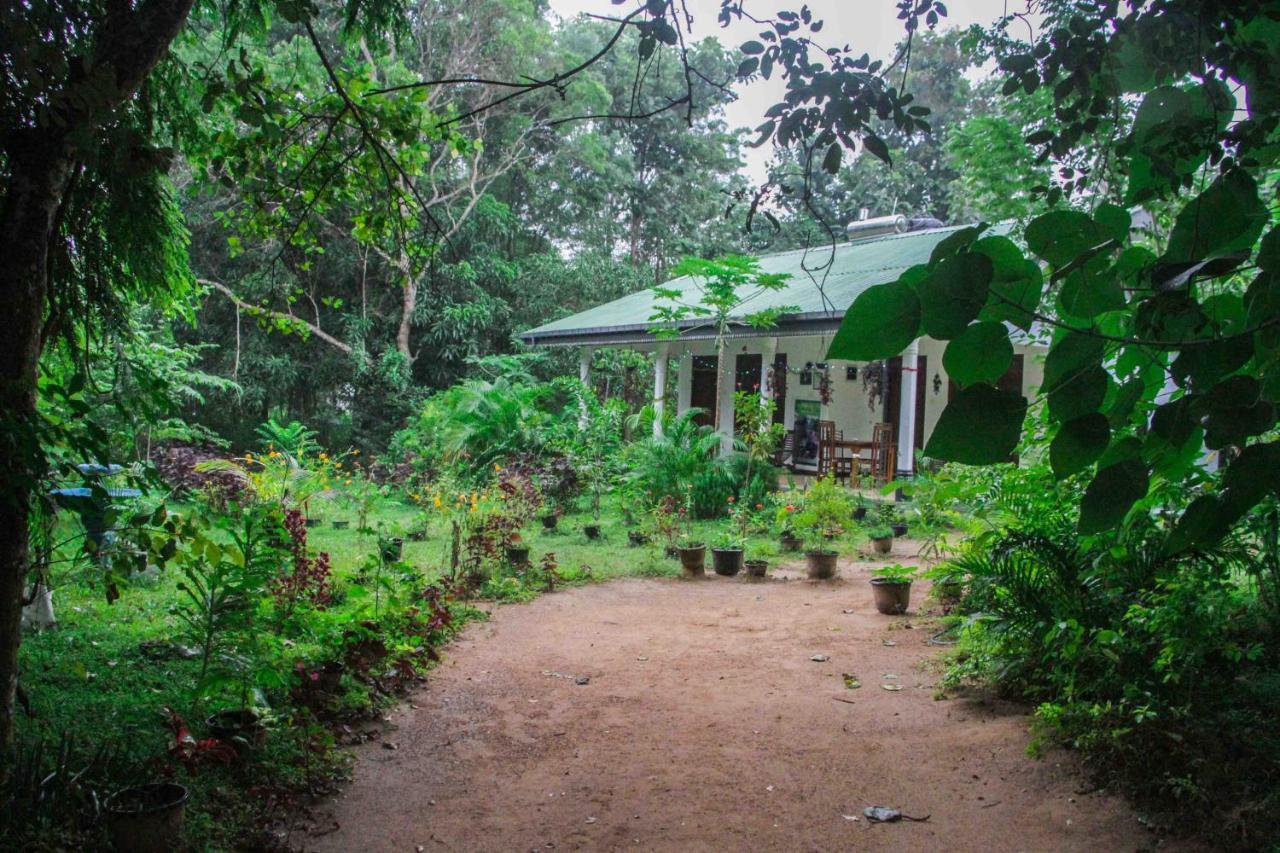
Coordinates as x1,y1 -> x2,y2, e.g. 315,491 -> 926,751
0,0 -> 193,745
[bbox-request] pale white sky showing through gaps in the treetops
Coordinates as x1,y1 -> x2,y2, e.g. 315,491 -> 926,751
550,0 -> 1025,182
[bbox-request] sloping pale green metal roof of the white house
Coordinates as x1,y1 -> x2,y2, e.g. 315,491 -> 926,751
520,225 -> 1002,346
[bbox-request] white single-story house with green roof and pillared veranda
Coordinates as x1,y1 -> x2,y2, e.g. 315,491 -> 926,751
521,216 -> 1043,475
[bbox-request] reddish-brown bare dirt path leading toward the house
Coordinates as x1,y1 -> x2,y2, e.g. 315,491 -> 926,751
307,561 -> 1174,853
